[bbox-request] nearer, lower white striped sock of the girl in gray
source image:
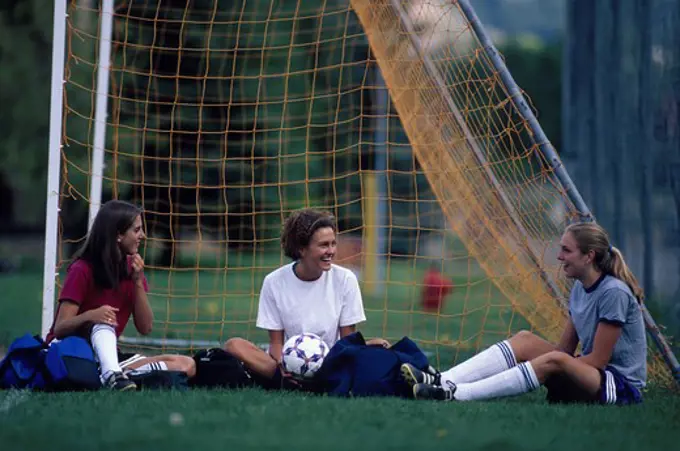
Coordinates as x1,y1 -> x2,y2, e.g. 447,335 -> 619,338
453,362 -> 541,401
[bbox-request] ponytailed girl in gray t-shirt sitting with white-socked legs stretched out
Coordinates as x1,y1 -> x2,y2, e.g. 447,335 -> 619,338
401,223 -> 647,404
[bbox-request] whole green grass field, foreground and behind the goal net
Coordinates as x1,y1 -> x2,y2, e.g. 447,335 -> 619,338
0,261 -> 680,451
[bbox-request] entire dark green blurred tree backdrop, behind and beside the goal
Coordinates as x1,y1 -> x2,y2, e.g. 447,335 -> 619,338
0,0 -> 560,252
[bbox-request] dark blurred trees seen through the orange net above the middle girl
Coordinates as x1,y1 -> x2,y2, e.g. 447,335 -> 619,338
107,0 -> 361,265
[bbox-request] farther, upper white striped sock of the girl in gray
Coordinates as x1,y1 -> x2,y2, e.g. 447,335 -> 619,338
441,340 -> 517,387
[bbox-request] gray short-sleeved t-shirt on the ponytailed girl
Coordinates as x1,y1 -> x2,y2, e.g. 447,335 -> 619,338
569,276 -> 647,388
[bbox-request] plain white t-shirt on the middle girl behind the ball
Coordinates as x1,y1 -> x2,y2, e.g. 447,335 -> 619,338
257,263 -> 366,347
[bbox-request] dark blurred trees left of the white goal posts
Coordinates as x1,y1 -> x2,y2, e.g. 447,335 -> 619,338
0,0 -> 52,225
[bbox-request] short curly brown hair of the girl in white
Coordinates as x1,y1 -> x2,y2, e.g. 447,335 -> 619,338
281,208 -> 337,260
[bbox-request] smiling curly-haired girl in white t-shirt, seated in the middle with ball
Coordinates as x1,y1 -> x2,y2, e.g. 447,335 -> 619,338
225,209 -> 389,386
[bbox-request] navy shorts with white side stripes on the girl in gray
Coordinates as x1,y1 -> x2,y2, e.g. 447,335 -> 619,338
545,368 -> 642,406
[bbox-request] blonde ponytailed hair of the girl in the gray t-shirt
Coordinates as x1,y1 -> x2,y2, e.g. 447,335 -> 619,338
565,222 -> 645,303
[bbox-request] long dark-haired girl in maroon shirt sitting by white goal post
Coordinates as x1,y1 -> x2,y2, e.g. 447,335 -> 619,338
47,200 -> 195,391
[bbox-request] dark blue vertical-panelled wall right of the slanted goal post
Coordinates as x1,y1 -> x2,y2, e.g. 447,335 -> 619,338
564,0 -> 680,341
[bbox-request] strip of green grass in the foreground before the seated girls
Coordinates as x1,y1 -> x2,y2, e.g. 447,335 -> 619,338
0,389 -> 680,451
